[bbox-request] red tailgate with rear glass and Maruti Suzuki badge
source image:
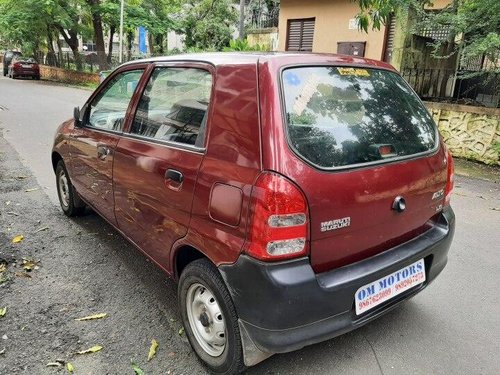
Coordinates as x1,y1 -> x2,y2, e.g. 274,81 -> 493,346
268,66 -> 446,272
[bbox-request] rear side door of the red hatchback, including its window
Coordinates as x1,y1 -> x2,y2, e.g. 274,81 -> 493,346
113,63 -> 213,269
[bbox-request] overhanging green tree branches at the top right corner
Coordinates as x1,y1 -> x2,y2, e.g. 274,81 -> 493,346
357,0 -> 500,72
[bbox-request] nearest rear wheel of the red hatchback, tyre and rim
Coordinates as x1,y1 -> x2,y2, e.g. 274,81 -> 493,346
178,259 -> 245,374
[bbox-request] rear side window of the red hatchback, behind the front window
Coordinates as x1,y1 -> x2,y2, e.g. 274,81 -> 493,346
130,67 -> 212,147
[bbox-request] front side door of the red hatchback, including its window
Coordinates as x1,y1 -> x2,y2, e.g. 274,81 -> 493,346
70,67 -> 144,224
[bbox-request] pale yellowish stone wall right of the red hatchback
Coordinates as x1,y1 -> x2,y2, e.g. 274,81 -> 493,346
425,102 -> 500,166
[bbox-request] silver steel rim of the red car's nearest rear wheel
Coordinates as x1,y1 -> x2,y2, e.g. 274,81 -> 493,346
186,283 -> 227,357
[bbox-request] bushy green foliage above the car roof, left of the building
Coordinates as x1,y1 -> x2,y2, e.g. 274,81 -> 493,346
180,0 -> 238,51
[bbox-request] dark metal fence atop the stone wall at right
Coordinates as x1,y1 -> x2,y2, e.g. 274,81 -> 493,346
401,68 -> 500,108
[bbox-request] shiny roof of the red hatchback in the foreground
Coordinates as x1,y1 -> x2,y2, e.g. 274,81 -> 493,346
124,52 -> 395,70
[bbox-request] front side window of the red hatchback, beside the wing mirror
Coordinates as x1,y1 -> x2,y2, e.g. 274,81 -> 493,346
88,69 -> 144,131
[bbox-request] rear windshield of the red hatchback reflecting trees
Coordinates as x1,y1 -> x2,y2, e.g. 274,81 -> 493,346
282,66 -> 437,169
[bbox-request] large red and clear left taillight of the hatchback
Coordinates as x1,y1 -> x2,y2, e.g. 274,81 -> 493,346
245,172 -> 309,260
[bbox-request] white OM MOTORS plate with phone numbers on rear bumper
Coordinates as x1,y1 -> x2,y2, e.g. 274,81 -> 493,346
354,259 -> 425,315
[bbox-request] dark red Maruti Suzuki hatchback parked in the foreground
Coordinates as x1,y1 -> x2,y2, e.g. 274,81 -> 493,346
52,53 -> 455,374
